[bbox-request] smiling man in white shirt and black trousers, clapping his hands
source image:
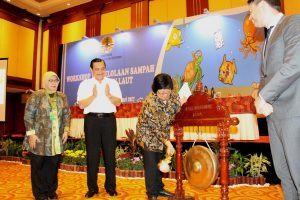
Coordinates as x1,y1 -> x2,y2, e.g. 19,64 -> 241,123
77,58 -> 122,198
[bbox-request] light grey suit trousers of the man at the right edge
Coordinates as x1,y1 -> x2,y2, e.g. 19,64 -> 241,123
267,116 -> 300,200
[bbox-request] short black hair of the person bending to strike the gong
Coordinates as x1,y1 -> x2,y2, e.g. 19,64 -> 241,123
152,73 -> 173,94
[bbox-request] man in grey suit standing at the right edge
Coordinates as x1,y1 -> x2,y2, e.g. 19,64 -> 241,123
248,0 -> 300,200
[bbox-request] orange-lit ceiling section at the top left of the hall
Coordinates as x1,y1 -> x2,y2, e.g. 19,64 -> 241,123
5,0 -> 92,17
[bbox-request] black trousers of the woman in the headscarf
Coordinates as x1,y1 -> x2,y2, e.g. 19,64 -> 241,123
29,153 -> 61,200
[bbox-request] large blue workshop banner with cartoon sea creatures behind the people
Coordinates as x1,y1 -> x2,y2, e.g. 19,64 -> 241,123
62,6 -> 264,105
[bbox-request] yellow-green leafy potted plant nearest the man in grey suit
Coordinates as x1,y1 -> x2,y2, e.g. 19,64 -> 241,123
244,153 -> 271,184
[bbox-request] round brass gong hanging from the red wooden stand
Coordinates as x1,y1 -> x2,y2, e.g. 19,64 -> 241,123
183,145 -> 219,189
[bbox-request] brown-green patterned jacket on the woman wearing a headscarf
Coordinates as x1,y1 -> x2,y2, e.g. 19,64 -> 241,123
24,90 -> 70,156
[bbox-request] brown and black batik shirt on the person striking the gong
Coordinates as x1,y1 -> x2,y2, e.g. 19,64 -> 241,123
136,91 -> 180,152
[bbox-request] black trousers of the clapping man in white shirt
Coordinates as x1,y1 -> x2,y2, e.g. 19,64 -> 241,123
84,115 -> 117,191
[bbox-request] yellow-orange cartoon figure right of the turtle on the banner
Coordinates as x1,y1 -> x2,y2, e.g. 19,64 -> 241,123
219,54 -> 237,85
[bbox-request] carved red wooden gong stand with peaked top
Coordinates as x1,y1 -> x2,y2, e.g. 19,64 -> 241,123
169,83 -> 239,200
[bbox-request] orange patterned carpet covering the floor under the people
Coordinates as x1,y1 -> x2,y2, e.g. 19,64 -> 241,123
0,161 -> 283,200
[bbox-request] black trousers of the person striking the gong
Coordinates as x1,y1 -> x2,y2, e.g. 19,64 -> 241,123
142,150 -> 164,196
